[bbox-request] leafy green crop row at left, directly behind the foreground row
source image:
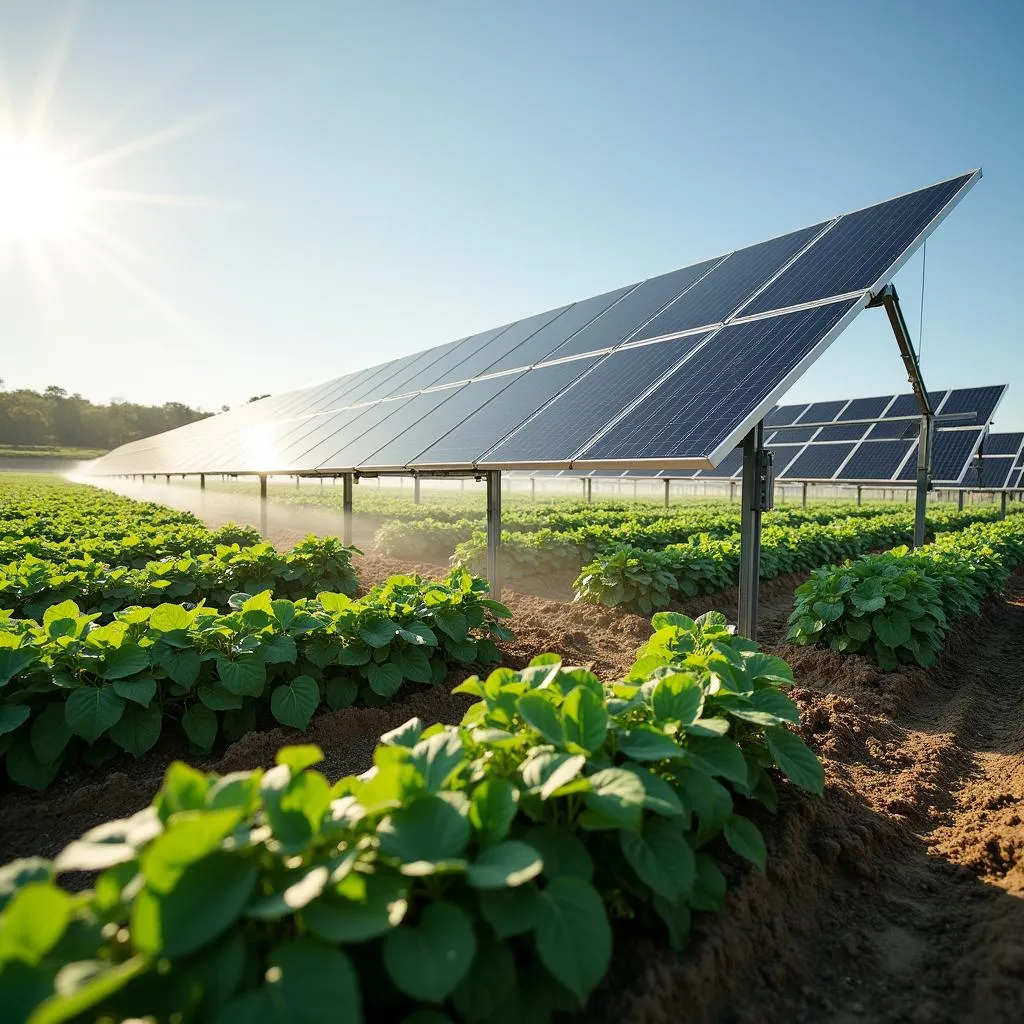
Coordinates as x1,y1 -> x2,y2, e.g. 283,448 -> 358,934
0,570 -> 509,788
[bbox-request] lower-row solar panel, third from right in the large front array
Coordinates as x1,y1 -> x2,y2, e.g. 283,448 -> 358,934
413,356 -> 597,466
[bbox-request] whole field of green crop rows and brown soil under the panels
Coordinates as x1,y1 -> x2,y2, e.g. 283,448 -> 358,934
0,476 -> 1024,1024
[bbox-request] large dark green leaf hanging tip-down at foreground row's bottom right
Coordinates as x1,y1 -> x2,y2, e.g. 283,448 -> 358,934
537,876 -> 611,1006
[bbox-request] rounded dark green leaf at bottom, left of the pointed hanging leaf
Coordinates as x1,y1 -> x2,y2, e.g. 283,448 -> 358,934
383,903 -> 476,1002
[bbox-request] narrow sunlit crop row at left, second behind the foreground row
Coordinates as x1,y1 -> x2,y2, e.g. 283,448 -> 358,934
0,535 -> 358,618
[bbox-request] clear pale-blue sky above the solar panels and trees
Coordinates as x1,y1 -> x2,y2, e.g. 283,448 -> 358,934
0,0 -> 1024,430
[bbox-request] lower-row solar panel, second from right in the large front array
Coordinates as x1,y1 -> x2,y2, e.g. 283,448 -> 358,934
481,335 -> 708,465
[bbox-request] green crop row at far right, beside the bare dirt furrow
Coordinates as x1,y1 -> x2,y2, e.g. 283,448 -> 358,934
788,516 -> 1024,670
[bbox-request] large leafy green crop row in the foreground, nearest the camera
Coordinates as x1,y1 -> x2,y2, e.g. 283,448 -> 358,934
0,615 -> 823,1024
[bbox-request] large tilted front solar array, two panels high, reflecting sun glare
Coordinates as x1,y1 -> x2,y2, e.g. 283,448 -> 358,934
92,171 -> 981,474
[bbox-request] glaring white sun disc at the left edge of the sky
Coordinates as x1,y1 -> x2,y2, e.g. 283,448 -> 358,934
0,136 -> 84,242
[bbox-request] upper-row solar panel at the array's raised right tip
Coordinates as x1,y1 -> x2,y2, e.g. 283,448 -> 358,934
742,174 -> 971,316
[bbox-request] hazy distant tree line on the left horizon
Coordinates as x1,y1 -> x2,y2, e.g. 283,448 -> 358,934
0,381 -> 211,450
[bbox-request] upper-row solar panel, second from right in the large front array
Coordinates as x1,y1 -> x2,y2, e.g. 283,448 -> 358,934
633,221 -> 827,341
